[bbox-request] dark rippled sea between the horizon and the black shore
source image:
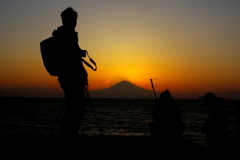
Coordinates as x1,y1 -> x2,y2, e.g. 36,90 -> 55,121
0,97 -> 240,146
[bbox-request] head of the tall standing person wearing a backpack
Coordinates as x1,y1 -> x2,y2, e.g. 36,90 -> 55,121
61,7 -> 78,29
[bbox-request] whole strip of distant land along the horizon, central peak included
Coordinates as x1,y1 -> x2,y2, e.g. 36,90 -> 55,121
0,81 -> 240,100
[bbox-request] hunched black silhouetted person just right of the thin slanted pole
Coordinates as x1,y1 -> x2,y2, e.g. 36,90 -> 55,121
149,90 -> 184,141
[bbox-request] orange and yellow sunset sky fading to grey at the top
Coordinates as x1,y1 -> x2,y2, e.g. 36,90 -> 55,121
0,0 -> 240,99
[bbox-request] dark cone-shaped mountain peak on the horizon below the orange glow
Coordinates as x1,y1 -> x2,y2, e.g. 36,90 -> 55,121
90,81 -> 154,99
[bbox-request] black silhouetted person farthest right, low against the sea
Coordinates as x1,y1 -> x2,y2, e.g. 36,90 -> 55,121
202,92 -> 228,153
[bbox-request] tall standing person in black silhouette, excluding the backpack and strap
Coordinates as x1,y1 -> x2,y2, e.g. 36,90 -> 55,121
52,7 -> 88,135
